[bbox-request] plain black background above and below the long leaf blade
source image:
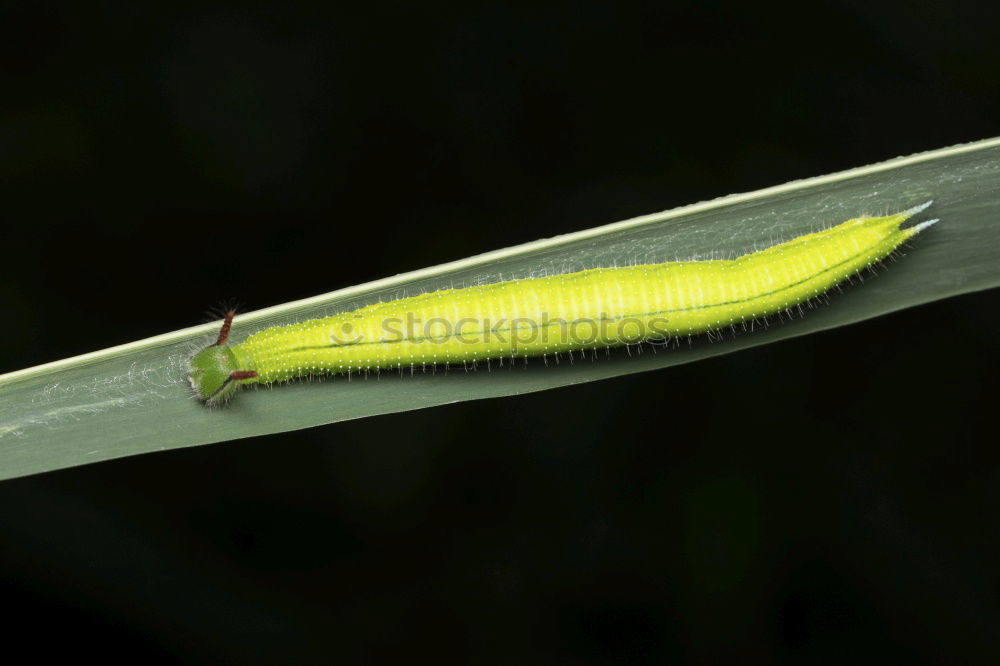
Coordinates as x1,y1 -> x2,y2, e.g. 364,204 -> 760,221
0,1 -> 1000,664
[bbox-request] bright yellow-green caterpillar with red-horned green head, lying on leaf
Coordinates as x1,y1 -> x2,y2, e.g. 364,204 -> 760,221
189,202 -> 937,405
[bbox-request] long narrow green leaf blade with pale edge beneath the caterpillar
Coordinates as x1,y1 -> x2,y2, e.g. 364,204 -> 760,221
0,139 -> 1000,478
